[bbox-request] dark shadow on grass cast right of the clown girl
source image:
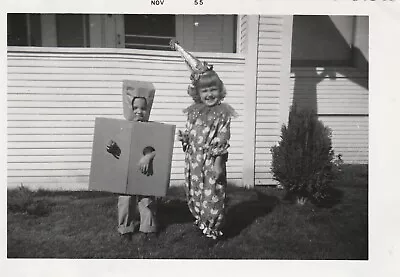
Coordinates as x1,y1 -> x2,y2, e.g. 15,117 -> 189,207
223,191 -> 280,239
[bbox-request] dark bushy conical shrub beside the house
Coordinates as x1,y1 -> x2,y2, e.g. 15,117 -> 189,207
271,106 -> 336,202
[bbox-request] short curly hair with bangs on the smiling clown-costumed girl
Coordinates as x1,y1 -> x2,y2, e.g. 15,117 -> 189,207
188,70 -> 226,103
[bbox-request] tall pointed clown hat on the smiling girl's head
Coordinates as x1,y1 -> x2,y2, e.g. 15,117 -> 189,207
170,40 -> 213,86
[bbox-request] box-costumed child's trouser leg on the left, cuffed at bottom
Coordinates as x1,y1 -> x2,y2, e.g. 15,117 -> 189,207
118,195 -> 137,234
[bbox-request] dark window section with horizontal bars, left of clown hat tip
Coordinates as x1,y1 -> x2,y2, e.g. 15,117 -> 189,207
124,14 -> 175,50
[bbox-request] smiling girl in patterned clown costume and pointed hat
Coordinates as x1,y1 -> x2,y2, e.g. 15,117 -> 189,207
171,41 -> 236,239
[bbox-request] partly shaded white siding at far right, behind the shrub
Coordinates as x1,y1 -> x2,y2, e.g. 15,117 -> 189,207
290,67 -> 369,164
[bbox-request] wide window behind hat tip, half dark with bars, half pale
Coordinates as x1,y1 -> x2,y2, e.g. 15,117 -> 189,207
124,15 -> 237,53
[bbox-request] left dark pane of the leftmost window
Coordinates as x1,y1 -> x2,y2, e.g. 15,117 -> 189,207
7,13 -> 28,46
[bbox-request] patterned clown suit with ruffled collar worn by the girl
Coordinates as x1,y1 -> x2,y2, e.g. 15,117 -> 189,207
184,104 -> 231,238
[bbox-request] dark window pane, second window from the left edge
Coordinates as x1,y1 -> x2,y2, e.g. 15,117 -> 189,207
56,14 -> 85,47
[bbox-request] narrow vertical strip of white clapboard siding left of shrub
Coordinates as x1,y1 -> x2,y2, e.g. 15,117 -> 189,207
255,16 -> 284,185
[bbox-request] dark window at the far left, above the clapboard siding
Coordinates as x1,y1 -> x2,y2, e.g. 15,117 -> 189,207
7,13 -> 42,46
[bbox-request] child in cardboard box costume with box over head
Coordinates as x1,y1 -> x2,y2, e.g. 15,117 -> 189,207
89,80 -> 175,240
